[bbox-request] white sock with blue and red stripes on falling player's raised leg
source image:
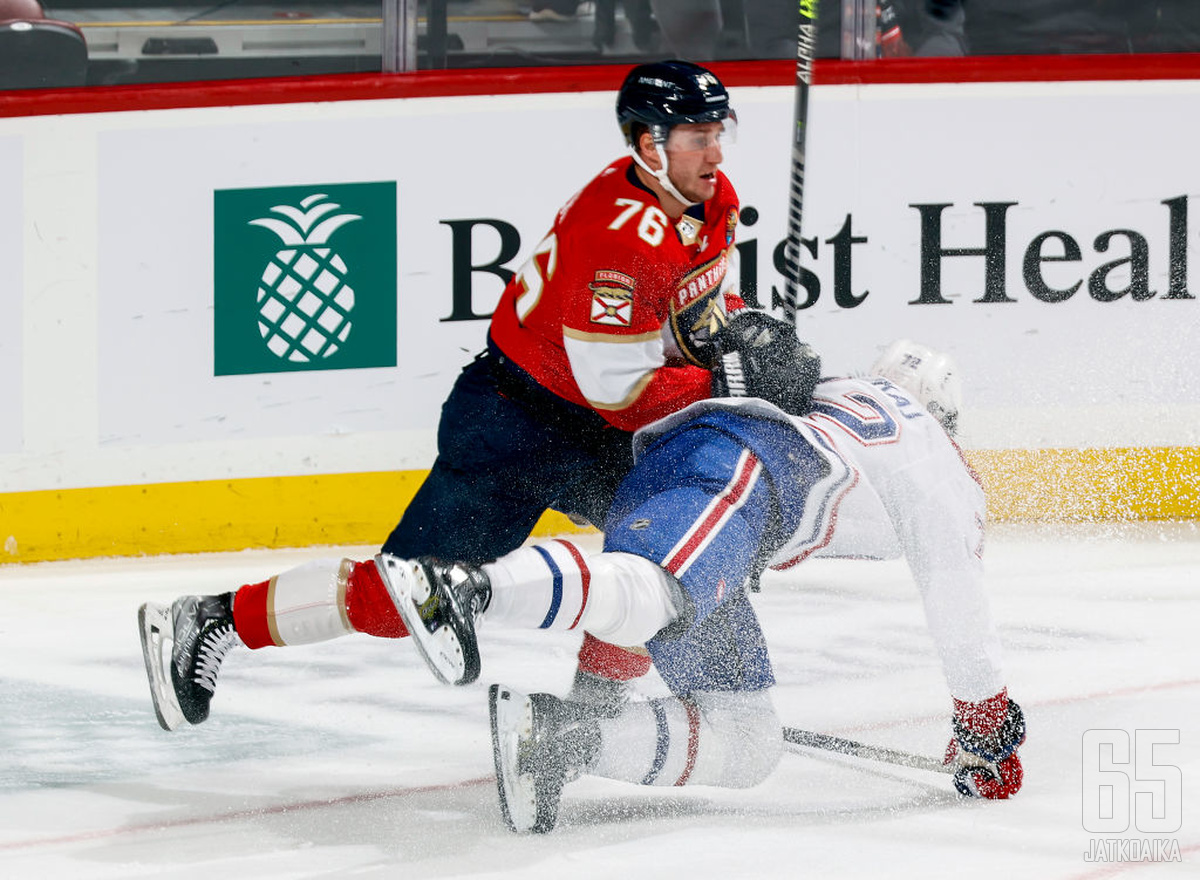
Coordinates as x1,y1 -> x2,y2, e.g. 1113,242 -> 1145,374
484,540 -> 677,645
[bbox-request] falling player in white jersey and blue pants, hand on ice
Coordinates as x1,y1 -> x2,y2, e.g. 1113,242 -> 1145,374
378,333 -> 1025,832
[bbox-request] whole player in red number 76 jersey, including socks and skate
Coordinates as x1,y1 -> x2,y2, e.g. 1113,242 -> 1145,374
139,61 -> 806,729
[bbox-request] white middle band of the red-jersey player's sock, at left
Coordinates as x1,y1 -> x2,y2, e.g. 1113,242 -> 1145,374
266,559 -> 354,645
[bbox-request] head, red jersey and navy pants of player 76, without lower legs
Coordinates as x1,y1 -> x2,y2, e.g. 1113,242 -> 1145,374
384,61 -> 744,559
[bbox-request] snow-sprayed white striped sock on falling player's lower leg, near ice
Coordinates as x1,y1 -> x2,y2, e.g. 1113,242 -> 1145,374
587,690 -> 784,789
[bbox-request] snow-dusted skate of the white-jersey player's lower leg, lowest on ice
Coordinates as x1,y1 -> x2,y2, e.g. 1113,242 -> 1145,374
487,684 -> 600,834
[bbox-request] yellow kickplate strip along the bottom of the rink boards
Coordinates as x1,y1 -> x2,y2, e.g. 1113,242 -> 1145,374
0,447 -> 1200,563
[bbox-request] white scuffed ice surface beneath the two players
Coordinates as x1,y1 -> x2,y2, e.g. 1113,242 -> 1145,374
0,523 -> 1200,880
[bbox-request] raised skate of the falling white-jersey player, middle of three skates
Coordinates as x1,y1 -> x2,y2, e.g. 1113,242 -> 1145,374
376,553 -> 492,684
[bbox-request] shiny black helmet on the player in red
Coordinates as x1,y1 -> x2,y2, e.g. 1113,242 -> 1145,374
617,60 -> 736,146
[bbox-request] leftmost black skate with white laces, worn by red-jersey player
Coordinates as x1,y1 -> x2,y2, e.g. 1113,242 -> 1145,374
138,593 -> 240,730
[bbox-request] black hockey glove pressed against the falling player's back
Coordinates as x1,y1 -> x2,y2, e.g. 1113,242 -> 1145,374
713,311 -> 821,415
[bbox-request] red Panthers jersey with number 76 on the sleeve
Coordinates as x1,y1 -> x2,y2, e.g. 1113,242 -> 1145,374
491,156 -> 742,431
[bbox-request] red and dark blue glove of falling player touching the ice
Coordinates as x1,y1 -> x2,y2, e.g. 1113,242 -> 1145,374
944,688 -> 1025,801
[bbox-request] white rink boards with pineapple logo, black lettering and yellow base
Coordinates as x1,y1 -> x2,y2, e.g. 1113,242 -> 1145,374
0,65 -> 1200,561
